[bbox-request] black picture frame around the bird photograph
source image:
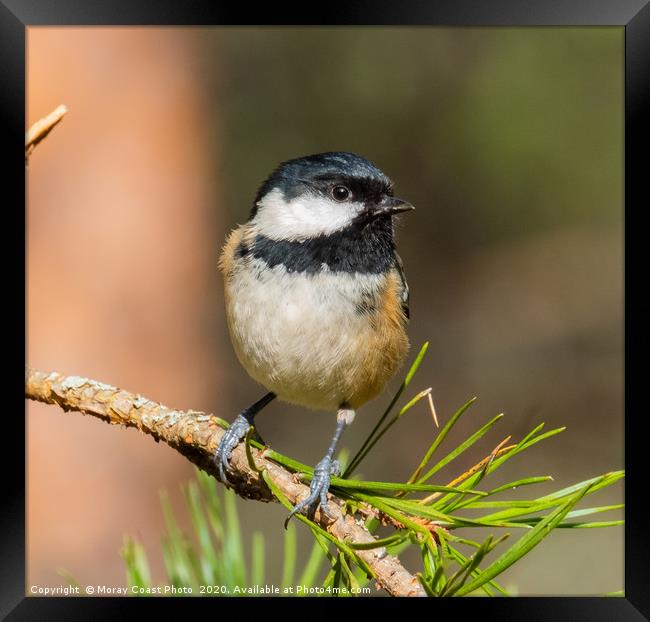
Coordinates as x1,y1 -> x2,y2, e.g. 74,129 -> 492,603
6,0 -> 650,622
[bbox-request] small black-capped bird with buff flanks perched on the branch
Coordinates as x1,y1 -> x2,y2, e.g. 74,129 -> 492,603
214,151 -> 415,525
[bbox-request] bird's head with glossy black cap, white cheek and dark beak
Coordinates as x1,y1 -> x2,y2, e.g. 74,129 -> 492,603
250,151 -> 414,240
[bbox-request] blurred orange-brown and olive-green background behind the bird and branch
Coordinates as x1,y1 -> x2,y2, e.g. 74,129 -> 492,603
27,28 -> 623,594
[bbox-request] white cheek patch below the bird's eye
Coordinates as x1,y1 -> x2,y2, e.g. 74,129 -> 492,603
254,188 -> 364,240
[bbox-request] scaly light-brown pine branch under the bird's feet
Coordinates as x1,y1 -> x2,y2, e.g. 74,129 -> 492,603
25,369 -> 425,596
